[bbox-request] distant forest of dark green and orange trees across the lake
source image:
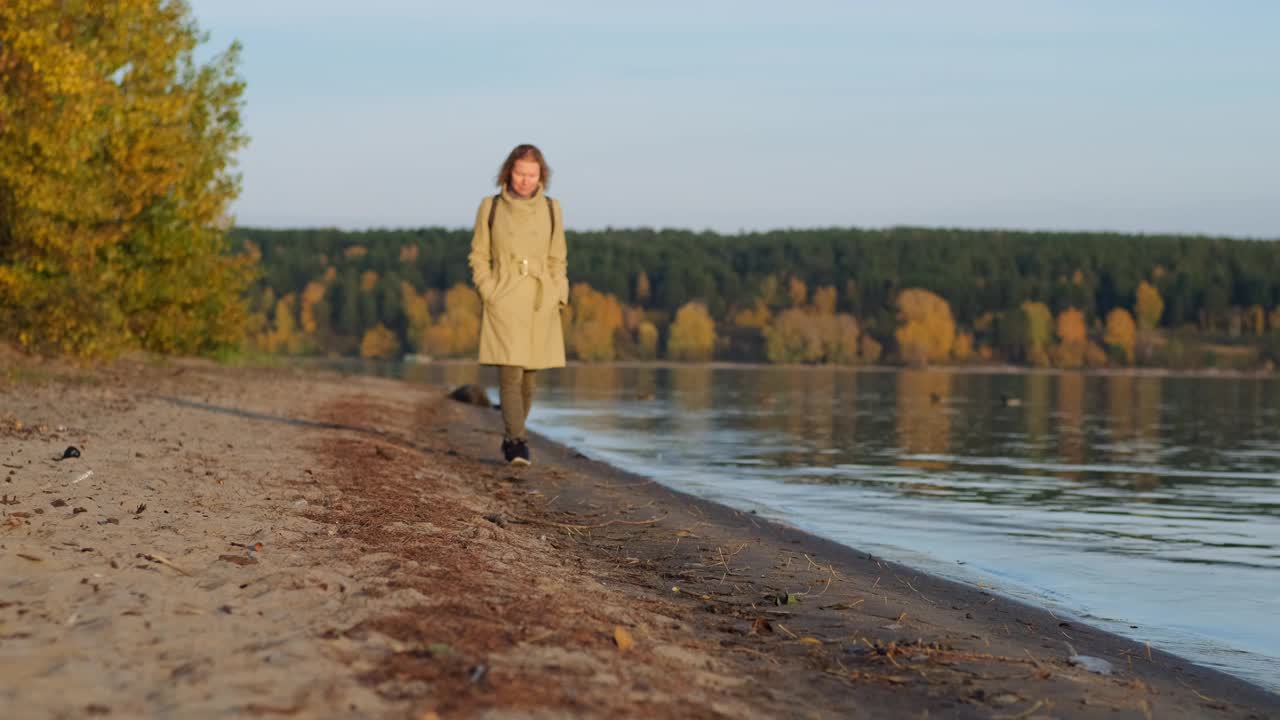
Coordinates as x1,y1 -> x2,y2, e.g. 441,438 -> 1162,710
232,228 -> 1280,369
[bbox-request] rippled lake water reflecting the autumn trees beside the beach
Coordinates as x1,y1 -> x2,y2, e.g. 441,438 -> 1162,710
360,364 -> 1280,691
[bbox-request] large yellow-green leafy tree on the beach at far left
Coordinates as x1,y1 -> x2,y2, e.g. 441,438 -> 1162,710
0,0 -> 252,356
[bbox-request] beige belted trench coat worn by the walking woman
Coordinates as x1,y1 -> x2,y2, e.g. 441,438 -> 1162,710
467,186 -> 568,370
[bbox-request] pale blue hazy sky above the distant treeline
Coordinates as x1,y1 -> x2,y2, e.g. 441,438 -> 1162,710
191,0 -> 1280,237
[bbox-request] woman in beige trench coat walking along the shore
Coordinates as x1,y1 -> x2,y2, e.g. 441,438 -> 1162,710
467,145 -> 568,465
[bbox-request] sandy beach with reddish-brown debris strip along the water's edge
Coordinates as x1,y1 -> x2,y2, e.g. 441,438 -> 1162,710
0,355 -> 1280,719
